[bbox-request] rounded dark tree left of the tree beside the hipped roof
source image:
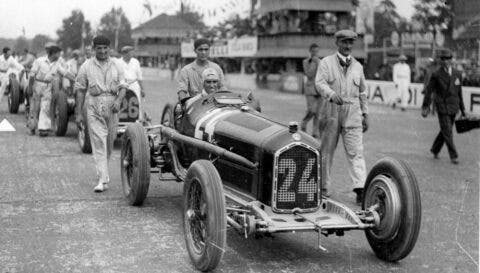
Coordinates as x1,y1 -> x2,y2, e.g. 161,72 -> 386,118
57,10 -> 92,50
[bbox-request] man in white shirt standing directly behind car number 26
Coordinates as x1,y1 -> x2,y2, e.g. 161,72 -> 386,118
118,46 -> 145,121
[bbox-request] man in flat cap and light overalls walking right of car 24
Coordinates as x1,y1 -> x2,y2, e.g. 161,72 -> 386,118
315,30 -> 368,204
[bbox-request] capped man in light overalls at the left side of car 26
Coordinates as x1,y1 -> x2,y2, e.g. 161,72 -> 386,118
28,42 -> 74,136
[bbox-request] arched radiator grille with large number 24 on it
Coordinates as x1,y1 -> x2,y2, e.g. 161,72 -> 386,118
272,144 -> 320,212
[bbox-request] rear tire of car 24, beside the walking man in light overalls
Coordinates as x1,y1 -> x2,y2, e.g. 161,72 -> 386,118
120,123 -> 150,206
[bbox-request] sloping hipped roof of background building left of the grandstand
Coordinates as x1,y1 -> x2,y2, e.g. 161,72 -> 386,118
132,13 -> 195,38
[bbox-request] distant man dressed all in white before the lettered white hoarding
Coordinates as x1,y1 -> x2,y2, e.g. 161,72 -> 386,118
392,54 -> 410,111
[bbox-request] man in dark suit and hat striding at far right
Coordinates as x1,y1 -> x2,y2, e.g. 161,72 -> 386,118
422,50 -> 465,164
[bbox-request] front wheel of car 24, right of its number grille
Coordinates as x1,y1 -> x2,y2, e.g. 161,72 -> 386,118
362,157 -> 422,262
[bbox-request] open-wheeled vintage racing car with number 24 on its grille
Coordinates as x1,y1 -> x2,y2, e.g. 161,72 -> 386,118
120,92 -> 421,271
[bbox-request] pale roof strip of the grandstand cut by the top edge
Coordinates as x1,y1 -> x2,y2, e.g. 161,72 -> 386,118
259,0 -> 354,14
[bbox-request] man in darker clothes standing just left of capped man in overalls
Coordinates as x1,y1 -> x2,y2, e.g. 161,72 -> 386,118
301,44 -> 322,138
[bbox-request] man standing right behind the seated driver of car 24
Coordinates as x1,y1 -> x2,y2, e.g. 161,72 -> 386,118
177,38 -> 225,103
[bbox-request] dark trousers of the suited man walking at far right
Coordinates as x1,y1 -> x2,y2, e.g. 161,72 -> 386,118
430,113 -> 458,159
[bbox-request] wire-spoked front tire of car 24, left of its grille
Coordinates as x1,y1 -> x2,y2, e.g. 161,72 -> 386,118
183,160 -> 227,271
